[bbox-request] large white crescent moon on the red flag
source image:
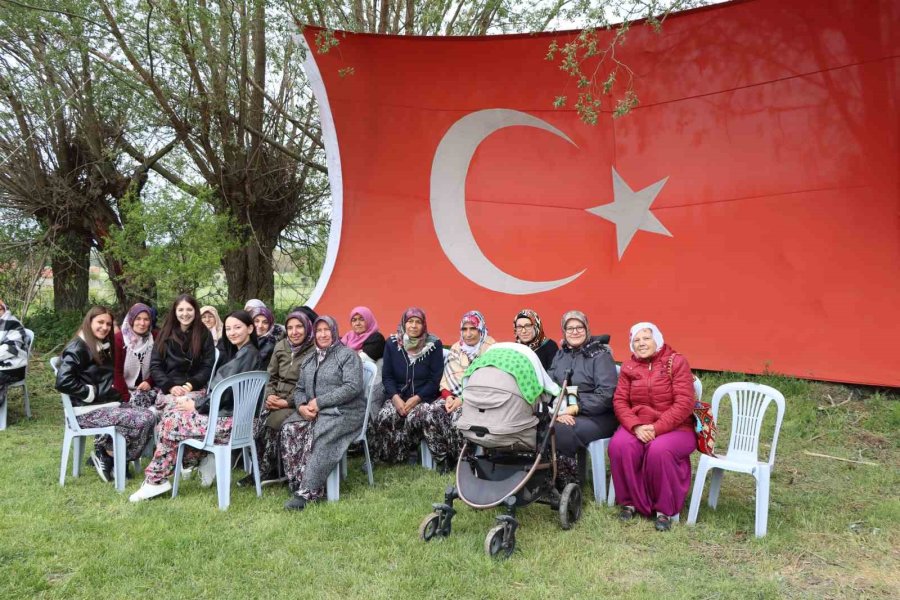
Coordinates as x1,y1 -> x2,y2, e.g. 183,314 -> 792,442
431,108 -> 584,295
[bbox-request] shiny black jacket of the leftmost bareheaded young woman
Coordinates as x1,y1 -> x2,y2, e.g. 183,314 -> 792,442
56,338 -> 122,406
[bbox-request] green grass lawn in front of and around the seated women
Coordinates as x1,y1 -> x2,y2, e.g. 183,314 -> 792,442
0,344 -> 900,600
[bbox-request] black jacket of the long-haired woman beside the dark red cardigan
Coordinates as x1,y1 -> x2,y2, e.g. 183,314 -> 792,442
150,327 -> 216,394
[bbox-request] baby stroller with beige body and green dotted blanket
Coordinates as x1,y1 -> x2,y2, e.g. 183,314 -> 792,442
419,343 -> 582,558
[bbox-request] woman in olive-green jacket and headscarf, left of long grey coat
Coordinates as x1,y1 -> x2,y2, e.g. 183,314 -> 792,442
238,312 -> 315,486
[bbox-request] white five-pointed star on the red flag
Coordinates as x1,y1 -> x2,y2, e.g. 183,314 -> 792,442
585,167 -> 672,260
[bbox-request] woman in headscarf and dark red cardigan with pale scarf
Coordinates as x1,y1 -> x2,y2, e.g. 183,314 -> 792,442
113,302 -> 156,408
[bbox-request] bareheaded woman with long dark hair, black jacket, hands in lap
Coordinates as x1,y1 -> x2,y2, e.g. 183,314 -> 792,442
150,294 -> 216,411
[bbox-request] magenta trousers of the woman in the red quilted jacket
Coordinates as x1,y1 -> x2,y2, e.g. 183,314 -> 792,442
609,427 -> 697,517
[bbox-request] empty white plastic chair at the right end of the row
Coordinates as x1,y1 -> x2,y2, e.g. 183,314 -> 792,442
687,383 -> 784,537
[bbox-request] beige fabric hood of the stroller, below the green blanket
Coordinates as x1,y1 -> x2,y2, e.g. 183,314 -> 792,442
456,367 -> 540,450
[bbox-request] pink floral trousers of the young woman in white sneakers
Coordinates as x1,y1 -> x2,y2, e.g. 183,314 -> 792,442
144,406 -> 233,484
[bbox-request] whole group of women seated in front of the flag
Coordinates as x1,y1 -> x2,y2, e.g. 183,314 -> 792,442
54,295 -> 696,530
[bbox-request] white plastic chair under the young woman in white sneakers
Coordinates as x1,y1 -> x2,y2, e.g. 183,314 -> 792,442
172,371 -> 269,510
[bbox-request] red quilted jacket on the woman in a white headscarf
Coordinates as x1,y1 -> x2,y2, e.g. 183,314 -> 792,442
613,344 -> 694,435
